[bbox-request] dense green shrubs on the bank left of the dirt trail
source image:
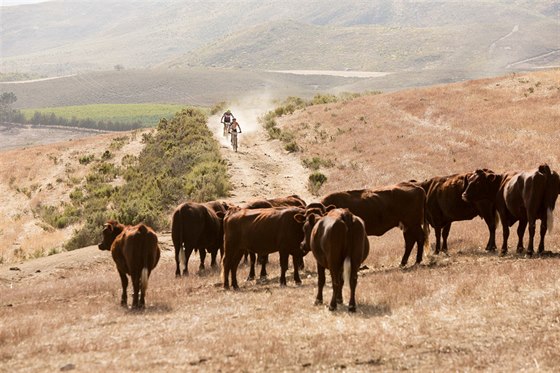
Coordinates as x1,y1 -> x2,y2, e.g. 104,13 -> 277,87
60,108 -> 231,250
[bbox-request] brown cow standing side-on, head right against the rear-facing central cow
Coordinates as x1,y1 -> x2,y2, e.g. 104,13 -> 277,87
222,207 -> 305,289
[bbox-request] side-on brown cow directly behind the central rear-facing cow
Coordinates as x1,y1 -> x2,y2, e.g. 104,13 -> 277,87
321,181 -> 430,267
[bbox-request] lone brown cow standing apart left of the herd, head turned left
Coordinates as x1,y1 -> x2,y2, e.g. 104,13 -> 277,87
98,220 -> 160,309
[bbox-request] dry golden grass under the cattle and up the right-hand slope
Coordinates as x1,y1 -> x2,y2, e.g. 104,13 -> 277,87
0,70 -> 560,372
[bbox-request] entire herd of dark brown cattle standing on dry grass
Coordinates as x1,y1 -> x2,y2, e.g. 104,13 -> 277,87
99,164 -> 560,311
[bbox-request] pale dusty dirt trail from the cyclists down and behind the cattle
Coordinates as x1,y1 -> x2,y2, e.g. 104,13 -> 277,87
0,99 -> 313,286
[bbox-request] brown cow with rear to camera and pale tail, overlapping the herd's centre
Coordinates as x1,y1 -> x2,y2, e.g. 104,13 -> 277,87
295,209 -> 369,312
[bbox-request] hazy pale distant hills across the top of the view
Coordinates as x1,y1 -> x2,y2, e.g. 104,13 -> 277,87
0,0 -> 560,76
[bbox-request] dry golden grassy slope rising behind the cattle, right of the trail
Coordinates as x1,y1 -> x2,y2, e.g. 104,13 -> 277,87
279,70 -> 560,193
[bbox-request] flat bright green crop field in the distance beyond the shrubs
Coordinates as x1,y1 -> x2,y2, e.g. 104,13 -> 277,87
21,103 -> 185,126
